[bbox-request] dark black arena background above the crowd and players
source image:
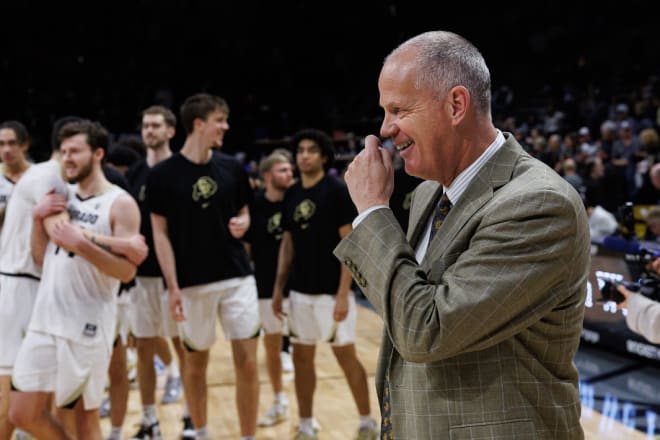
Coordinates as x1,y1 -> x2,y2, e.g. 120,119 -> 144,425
0,0 -> 660,160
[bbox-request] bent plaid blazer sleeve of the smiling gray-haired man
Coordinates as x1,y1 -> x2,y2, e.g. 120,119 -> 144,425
335,189 -> 589,362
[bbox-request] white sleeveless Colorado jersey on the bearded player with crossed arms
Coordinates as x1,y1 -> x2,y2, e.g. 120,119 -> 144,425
30,185 -> 125,350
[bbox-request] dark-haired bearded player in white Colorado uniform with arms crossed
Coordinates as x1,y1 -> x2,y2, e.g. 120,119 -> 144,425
9,120 -> 147,439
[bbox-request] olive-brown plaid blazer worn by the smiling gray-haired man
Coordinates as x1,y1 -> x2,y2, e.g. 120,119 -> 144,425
335,133 -> 590,440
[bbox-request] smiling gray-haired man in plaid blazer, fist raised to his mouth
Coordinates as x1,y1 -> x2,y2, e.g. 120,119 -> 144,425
335,31 -> 590,440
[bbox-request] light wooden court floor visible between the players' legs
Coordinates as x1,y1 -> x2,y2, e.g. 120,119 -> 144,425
102,306 -> 651,440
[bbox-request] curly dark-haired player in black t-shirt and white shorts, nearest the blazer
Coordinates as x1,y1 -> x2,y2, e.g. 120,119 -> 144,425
273,129 -> 378,438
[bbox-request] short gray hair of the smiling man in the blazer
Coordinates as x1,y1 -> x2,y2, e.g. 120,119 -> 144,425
385,31 -> 491,115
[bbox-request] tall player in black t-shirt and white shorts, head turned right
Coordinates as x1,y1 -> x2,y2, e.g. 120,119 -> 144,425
147,93 -> 261,439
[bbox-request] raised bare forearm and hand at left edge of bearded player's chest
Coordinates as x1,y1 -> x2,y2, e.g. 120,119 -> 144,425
30,189 -> 69,266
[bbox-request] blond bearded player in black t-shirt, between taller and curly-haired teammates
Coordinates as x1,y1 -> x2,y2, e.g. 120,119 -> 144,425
245,150 -> 293,426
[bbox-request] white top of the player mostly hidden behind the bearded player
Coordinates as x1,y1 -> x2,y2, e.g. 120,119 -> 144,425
0,159 -> 66,278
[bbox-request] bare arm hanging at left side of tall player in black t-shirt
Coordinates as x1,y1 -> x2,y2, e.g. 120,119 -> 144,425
151,212 -> 185,321
